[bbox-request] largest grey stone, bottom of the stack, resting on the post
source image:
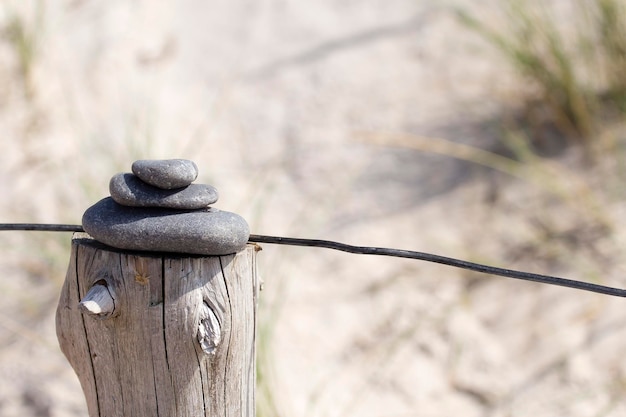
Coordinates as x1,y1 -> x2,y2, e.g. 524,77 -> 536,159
83,197 -> 250,255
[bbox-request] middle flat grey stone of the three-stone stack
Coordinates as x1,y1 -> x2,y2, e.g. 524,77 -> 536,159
109,173 -> 218,210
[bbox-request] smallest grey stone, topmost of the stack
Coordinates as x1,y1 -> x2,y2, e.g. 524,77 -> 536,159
131,159 -> 198,190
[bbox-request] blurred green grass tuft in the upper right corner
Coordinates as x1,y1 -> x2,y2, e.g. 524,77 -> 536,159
457,0 -> 626,146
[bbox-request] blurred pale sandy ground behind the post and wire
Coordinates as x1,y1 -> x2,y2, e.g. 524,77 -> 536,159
0,0 -> 626,417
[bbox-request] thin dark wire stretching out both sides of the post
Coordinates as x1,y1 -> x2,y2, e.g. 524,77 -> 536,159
0,223 -> 626,297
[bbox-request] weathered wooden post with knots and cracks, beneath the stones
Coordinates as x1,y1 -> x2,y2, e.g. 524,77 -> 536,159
56,234 -> 258,417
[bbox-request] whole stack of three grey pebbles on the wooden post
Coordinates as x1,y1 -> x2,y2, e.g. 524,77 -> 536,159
83,159 -> 250,255
